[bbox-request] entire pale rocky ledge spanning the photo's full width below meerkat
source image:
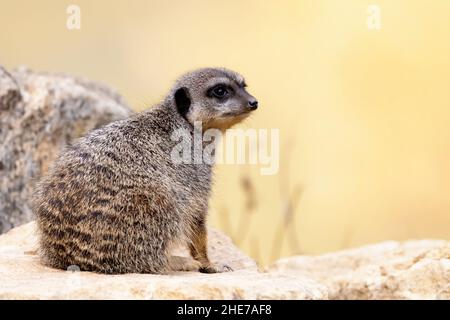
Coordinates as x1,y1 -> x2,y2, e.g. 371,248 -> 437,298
0,222 -> 450,299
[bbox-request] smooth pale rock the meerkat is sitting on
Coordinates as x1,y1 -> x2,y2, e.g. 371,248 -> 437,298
0,222 -> 327,299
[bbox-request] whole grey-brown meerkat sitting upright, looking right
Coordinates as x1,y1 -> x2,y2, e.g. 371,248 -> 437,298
33,68 -> 258,274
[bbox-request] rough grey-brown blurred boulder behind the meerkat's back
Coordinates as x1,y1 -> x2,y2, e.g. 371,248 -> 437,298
0,66 -> 131,234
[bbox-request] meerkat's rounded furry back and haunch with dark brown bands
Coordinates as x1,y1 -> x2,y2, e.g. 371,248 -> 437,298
35,107 -> 187,273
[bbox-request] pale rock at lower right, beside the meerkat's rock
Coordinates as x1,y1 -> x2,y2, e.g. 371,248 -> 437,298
268,240 -> 450,299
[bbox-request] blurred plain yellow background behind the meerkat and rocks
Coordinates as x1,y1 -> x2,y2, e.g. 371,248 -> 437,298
0,0 -> 450,264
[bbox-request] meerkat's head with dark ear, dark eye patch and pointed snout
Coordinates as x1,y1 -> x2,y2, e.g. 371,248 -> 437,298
171,68 -> 258,130
